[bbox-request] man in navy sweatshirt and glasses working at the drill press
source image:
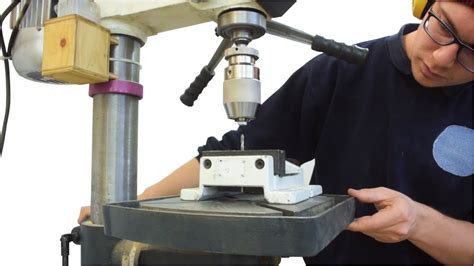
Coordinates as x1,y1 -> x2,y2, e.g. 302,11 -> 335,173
79,0 -> 474,264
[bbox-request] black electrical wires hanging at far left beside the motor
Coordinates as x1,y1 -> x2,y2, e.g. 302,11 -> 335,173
0,0 -> 31,157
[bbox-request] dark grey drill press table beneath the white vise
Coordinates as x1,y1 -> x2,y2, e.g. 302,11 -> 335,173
104,194 -> 355,257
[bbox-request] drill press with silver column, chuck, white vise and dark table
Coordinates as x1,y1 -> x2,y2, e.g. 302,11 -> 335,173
8,0 -> 367,265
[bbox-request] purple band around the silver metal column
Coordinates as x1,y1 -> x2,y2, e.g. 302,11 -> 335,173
89,80 -> 143,99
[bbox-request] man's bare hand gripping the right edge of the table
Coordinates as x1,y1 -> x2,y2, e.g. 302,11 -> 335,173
347,187 -> 420,243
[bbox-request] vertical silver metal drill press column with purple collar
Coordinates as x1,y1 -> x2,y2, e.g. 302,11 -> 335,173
90,35 -> 142,225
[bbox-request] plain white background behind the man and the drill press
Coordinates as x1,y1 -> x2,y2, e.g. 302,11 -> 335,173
0,0 -> 416,265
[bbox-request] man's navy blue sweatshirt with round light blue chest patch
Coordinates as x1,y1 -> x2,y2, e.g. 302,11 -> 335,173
199,25 -> 473,264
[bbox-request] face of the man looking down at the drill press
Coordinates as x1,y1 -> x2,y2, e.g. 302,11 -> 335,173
405,1 -> 474,87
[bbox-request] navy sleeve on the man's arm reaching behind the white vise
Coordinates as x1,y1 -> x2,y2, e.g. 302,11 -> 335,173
197,55 -> 337,163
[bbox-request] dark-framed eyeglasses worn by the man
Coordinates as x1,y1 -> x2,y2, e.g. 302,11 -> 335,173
423,8 -> 474,73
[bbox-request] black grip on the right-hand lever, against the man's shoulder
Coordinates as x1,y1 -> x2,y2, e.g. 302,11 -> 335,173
311,35 -> 369,66
